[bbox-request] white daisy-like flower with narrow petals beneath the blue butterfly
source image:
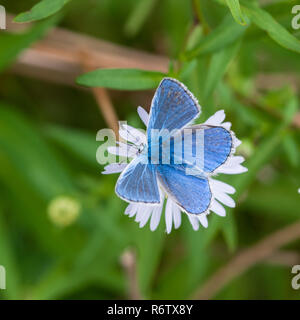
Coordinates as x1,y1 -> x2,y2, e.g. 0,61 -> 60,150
102,107 -> 248,233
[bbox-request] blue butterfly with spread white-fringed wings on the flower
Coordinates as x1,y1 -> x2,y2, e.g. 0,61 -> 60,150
115,78 -> 233,214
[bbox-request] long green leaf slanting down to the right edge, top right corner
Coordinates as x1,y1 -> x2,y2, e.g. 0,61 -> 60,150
242,1 -> 300,53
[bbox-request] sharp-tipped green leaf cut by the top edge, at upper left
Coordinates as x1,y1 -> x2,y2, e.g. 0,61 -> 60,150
14,0 -> 70,22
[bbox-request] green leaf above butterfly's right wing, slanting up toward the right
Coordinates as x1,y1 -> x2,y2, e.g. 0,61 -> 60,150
182,16 -> 248,60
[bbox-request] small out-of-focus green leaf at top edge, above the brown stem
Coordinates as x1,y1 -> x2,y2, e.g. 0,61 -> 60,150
124,0 -> 157,37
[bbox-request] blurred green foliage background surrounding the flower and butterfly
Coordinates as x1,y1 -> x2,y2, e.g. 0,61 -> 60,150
0,0 -> 300,299
